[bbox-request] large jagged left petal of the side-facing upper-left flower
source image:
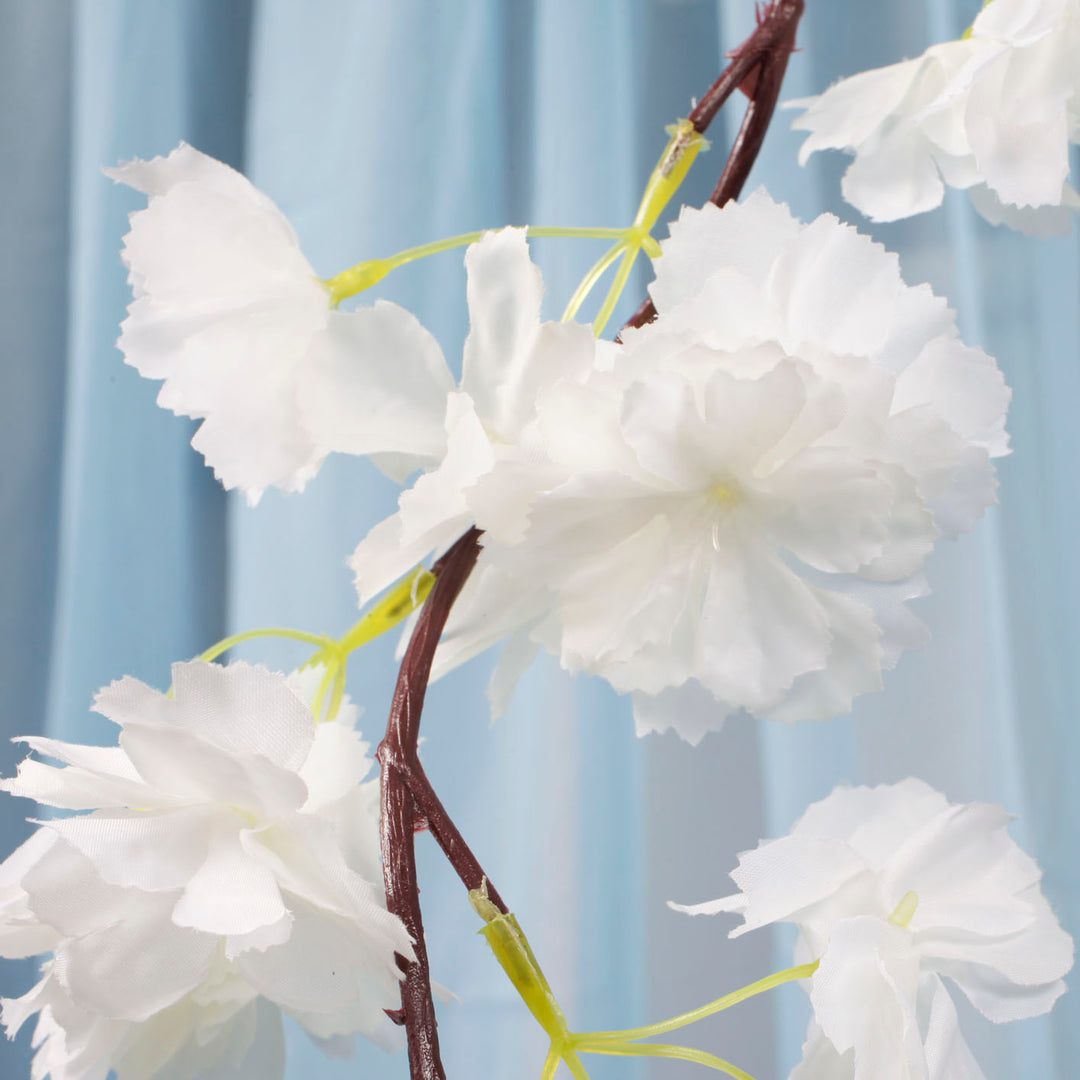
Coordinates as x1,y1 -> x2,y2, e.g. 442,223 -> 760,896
109,145 -> 329,503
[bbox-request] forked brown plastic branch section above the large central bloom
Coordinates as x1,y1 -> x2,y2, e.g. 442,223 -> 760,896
623,0 -> 805,329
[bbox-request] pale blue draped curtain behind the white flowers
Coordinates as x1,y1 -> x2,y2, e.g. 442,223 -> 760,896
0,0 -> 1080,1080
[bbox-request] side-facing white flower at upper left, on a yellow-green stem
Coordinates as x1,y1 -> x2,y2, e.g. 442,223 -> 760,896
106,143 -> 453,504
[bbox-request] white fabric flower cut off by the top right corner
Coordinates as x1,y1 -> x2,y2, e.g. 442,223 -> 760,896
788,0 -> 1080,235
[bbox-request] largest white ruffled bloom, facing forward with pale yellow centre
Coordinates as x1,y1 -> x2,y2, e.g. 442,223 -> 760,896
447,192 -> 1009,742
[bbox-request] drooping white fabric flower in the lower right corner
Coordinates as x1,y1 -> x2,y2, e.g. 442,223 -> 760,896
672,779 -> 1072,1080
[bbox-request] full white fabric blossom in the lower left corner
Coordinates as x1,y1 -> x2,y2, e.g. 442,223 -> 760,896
0,661 -> 413,1080
